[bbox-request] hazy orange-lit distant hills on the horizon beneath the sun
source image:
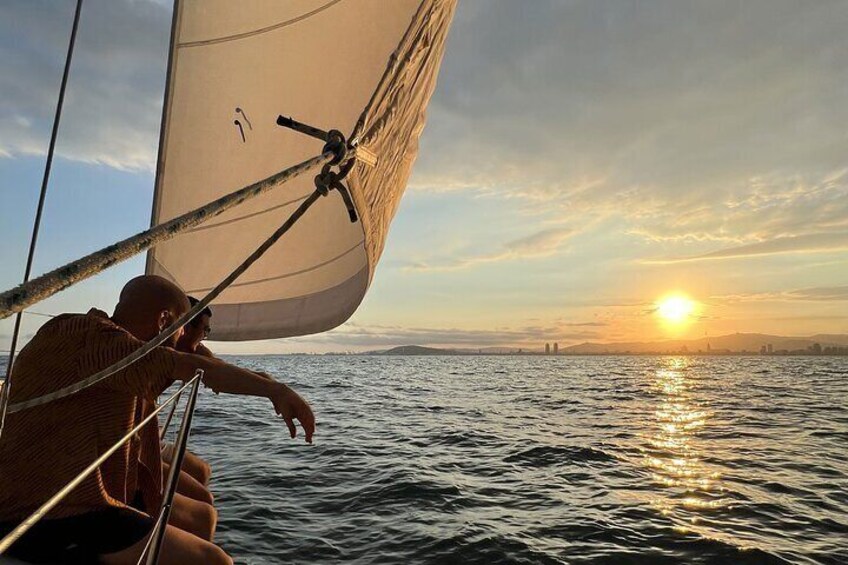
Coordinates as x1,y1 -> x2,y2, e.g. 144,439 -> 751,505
561,333 -> 848,354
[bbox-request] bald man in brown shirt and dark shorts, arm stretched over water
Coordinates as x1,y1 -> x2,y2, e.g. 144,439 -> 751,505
0,276 -> 315,564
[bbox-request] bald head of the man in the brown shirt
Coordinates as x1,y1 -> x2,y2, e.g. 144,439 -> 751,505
112,275 -> 189,346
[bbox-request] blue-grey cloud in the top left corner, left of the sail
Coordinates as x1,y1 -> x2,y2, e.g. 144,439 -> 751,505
0,0 -> 170,170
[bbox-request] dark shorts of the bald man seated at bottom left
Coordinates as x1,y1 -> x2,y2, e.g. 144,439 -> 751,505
0,508 -> 154,563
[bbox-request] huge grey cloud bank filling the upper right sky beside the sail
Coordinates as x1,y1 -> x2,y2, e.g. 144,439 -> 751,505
413,0 -> 848,245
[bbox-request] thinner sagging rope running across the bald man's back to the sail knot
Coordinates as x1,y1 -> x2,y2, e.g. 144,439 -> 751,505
4,186 -> 332,414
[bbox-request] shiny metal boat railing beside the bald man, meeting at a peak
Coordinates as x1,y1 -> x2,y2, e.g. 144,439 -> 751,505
0,369 -> 203,565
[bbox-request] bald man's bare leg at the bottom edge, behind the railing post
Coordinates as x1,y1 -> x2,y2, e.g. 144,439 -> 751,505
100,526 -> 233,565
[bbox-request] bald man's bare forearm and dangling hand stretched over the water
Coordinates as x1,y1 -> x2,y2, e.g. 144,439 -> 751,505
173,350 -> 315,443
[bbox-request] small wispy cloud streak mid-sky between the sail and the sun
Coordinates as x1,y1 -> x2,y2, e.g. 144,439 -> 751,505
406,228 -> 574,271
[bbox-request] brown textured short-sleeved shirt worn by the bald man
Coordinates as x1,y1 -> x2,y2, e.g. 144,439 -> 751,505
0,309 -> 175,521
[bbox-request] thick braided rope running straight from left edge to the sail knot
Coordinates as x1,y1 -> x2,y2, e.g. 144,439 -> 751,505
0,151 -> 336,320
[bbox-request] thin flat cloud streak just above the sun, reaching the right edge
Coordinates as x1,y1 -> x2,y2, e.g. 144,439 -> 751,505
645,232 -> 848,264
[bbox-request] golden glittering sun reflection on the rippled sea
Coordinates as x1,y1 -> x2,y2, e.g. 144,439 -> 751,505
643,357 -> 725,524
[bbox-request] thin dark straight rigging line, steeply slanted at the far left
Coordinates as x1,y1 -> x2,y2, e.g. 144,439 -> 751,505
0,0 -> 82,434
